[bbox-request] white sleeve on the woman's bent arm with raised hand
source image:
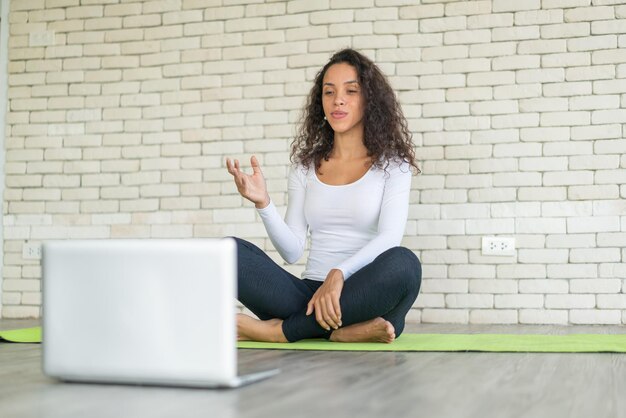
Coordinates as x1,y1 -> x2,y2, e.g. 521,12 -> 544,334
257,165 -> 308,264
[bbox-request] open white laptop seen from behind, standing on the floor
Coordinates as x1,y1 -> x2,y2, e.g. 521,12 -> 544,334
42,238 -> 278,388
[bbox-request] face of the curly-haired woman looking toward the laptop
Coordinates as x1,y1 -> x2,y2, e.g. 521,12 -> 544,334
322,62 -> 364,133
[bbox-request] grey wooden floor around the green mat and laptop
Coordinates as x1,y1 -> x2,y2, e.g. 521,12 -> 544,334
0,320 -> 626,418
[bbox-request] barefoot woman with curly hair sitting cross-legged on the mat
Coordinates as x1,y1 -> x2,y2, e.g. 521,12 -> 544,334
226,49 -> 421,342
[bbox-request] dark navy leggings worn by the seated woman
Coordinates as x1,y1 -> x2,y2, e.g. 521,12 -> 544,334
233,237 -> 422,342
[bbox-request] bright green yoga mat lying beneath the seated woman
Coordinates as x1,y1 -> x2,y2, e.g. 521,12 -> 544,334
0,327 -> 626,353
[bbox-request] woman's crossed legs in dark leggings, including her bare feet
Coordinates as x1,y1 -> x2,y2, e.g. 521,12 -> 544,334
235,238 -> 421,342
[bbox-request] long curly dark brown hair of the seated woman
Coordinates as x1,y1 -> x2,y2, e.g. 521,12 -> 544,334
290,48 -> 420,174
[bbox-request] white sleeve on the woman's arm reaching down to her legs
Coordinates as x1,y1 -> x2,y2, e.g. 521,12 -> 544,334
335,162 -> 412,279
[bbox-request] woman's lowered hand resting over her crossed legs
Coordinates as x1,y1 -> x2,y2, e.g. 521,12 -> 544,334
306,269 -> 344,331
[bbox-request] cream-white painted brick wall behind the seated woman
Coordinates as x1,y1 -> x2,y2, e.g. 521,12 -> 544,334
2,0 -> 626,325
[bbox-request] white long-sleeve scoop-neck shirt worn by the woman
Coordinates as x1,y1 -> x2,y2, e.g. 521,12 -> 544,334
257,161 -> 411,281
